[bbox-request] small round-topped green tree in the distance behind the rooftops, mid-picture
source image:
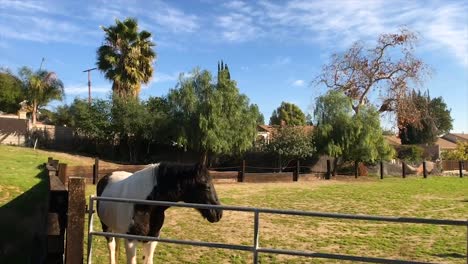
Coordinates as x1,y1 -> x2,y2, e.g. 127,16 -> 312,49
270,102 -> 306,126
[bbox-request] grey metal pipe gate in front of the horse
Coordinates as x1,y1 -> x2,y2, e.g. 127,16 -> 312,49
87,196 -> 468,264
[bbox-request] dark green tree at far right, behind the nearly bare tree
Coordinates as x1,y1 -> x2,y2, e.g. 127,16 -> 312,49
399,91 -> 453,144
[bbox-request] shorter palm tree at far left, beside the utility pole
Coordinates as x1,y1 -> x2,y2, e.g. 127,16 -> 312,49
19,67 -> 64,125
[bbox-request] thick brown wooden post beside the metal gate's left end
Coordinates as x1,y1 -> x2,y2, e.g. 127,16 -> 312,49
65,177 -> 86,264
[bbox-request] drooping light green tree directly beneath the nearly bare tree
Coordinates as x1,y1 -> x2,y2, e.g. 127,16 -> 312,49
314,91 -> 394,173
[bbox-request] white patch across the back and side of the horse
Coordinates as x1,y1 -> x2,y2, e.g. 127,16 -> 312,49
98,164 -> 159,233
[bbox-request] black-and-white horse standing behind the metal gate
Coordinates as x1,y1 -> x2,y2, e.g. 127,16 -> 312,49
97,163 -> 223,264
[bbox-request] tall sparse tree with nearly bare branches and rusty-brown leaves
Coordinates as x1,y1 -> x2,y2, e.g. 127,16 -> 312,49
315,28 -> 429,126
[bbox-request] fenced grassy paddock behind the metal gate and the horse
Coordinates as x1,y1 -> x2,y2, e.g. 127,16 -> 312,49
87,176 -> 468,263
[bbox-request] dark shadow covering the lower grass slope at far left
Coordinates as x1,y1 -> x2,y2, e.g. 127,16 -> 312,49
0,170 -> 49,263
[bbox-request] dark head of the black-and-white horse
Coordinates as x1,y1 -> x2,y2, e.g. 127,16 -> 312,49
182,164 -> 223,223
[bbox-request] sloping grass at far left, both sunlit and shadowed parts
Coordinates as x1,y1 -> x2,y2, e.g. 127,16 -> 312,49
0,145 -> 90,263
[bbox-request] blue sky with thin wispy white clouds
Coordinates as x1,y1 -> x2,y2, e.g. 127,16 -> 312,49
0,0 -> 468,133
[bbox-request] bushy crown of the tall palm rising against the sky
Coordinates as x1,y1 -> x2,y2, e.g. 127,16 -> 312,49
96,18 -> 156,97
